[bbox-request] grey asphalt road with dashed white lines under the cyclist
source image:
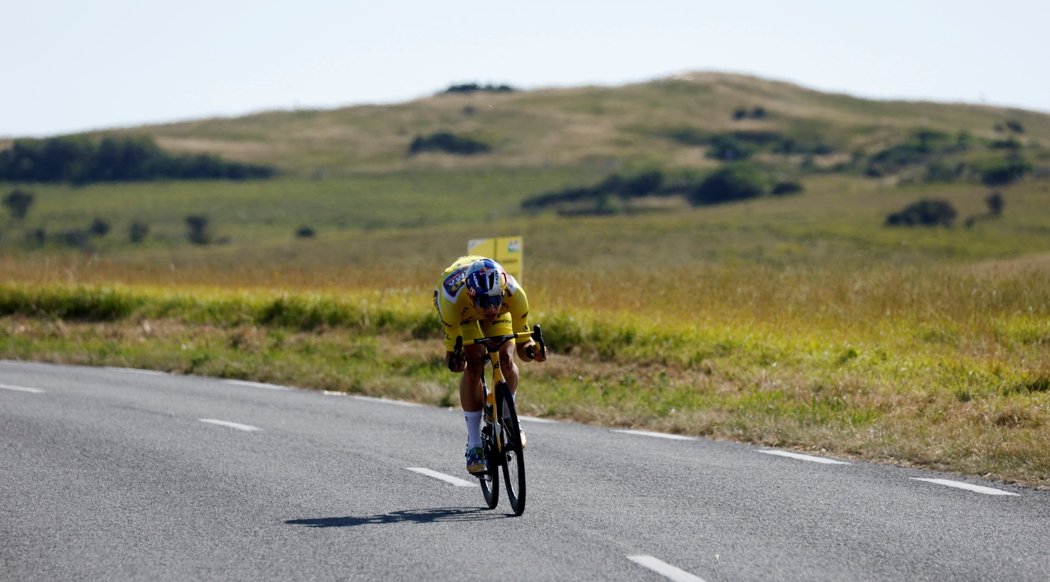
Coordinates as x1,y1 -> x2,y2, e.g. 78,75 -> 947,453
0,361 -> 1050,582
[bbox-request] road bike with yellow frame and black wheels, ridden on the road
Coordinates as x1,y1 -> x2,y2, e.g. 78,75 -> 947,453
456,326 -> 546,516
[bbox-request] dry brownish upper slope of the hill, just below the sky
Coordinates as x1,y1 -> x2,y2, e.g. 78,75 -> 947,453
57,74 -> 1050,175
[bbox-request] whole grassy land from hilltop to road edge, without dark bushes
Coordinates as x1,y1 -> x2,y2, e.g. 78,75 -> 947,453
0,76 -> 1050,486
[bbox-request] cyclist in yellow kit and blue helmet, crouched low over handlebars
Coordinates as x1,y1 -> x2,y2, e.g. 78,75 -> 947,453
434,256 -> 547,474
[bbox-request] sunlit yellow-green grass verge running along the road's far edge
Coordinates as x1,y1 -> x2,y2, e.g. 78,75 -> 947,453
0,284 -> 1050,487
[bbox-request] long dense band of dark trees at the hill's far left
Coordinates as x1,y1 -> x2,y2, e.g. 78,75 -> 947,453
0,136 -> 276,184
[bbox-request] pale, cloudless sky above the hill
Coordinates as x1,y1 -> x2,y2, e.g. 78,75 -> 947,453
0,0 -> 1050,138
